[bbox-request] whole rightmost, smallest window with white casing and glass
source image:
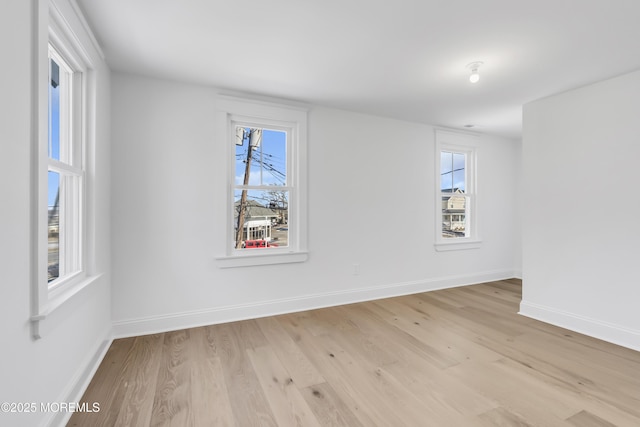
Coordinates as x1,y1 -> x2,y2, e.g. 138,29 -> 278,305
436,131 -> 479,250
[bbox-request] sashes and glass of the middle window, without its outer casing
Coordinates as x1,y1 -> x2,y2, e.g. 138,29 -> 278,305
233,127 -> 292,251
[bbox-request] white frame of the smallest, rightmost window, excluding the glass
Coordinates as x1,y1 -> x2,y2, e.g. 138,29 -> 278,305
434,129 -> 482,251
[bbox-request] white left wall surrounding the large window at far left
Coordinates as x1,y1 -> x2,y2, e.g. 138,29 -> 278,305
0,0 -> 111,427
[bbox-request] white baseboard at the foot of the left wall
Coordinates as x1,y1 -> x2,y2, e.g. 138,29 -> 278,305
40,333 -> 113,426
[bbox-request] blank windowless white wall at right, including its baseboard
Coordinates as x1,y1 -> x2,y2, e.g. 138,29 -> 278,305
521,72 -> 640,350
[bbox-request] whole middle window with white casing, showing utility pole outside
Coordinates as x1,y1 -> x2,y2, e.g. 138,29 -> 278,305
218,97 -> 307,267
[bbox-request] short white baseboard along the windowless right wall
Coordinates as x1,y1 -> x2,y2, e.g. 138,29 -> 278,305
518,300 -> 640,351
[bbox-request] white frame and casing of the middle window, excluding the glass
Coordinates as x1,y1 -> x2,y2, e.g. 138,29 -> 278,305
216,95 -> 308,268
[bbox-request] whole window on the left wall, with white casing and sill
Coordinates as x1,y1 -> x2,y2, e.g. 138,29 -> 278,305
31,1 -> 101,338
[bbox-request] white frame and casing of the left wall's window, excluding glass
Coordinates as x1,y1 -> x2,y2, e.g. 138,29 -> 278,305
31,1 -> 101,339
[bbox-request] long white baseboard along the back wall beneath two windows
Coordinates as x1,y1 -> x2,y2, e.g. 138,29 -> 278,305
113,270 -> 514,338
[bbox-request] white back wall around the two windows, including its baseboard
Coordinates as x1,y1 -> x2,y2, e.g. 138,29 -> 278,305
112,73 -> 519,336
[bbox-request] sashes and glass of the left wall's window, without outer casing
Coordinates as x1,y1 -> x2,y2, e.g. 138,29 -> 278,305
47,45 -> 84,287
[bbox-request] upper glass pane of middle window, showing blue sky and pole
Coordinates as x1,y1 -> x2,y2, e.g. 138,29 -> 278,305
235,126 -> 287,186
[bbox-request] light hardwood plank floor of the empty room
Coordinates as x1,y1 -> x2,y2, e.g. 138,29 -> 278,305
68,280 -> 640,427
